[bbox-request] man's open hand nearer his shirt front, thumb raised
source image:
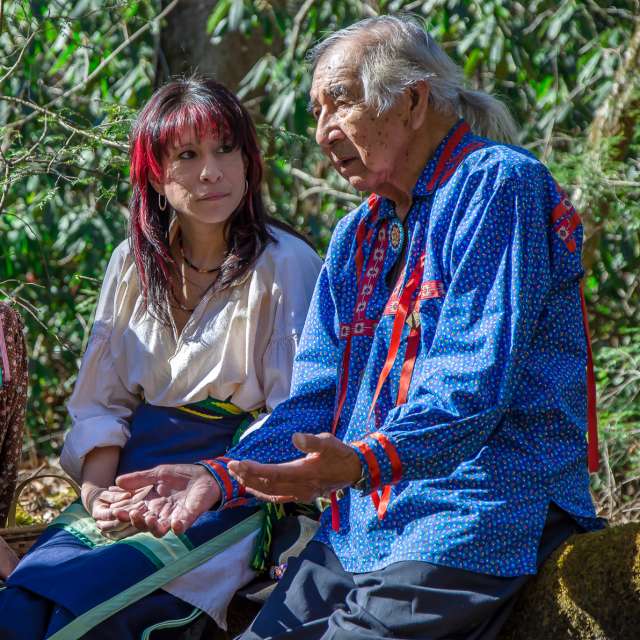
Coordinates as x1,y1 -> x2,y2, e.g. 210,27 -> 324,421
228,433 -> 362,502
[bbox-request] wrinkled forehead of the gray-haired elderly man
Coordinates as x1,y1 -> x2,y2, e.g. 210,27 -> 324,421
309,42 -> 362,102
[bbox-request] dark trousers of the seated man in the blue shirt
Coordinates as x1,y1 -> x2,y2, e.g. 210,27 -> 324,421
239,505 -> 579,640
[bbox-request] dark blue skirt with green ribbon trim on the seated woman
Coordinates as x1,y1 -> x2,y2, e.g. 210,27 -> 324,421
0,401 -> 263,640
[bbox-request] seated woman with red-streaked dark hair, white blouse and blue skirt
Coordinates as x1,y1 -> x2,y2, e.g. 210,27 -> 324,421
0,79 -> 320,638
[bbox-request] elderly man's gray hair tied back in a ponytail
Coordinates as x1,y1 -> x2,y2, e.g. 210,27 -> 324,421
308,15 -> 517,142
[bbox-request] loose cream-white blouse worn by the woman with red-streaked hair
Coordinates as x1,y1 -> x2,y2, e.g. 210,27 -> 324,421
60,227 -> 322,481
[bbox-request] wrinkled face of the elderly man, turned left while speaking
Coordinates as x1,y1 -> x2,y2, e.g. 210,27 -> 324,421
311,43 -> 412,192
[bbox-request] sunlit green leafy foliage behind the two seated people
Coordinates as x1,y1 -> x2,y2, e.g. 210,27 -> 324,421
0,0 -> 640,520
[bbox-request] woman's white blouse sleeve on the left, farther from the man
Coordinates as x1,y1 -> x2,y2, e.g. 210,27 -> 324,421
60,241 -> 140,481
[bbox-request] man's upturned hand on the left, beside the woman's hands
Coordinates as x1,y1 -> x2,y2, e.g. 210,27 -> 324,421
114,464 -> 220,538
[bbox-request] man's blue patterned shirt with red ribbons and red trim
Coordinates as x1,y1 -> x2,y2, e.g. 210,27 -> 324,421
202,121 -> 602,576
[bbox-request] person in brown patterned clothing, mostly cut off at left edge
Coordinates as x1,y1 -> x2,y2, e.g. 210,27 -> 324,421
0,303 -> 27,579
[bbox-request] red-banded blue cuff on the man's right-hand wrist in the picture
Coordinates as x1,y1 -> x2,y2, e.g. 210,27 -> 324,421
349,431 -> 402,495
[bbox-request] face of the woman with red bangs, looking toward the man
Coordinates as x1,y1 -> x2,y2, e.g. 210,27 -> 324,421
150,126 -> 246,224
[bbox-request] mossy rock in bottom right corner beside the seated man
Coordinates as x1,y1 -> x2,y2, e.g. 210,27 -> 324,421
500,523 -> 640,640
